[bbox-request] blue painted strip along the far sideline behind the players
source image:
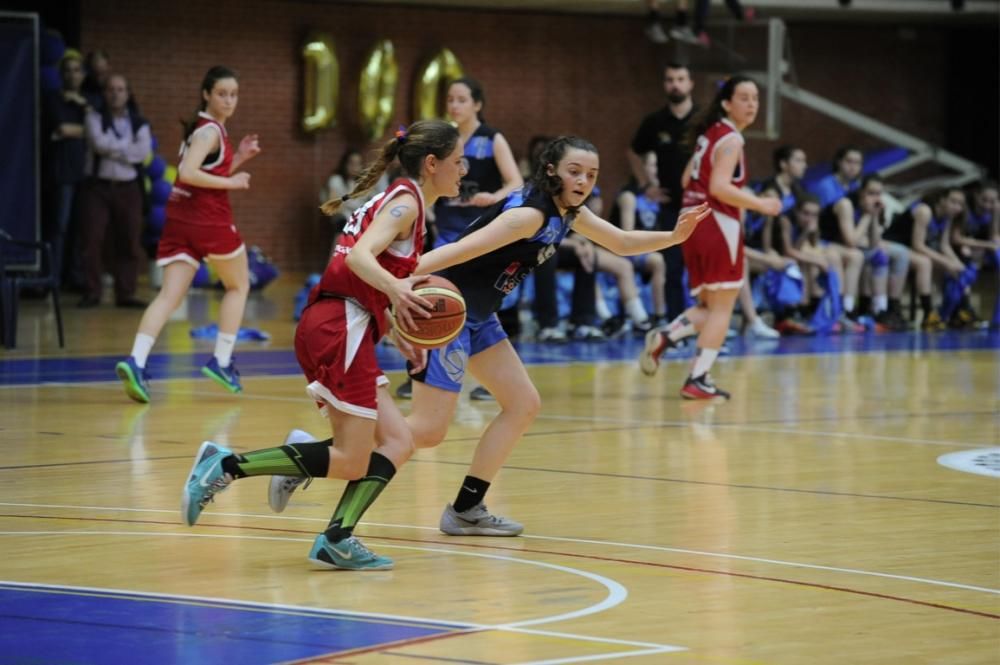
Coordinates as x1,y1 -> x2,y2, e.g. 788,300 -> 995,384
0,330 -> 1000,385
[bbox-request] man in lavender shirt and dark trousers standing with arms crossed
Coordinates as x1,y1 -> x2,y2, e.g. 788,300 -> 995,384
78,74 -> 153,308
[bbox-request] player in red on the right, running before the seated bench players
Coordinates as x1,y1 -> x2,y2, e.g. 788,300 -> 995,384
639,76 -> 781,399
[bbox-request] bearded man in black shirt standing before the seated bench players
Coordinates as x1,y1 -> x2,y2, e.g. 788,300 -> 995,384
628,62 -> 697,319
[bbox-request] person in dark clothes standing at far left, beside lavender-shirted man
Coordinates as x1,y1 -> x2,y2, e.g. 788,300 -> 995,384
44,49 -> 88,287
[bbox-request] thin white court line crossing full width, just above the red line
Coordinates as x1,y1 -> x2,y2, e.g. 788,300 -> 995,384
0,501 -> 1000,595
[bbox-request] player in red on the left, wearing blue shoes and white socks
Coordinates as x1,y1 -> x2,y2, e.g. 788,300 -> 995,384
115,66 -> 260,402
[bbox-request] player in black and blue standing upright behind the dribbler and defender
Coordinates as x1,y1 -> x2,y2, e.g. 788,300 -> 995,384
396,76 -> 524,401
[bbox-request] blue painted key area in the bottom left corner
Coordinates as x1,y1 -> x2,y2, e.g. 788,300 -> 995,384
0,584 -> 462,665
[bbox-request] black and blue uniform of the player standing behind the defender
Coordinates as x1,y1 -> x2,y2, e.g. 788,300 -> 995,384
434,125 -> 503,247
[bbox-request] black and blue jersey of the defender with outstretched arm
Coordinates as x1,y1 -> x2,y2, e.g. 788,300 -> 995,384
440,189 -> 577,321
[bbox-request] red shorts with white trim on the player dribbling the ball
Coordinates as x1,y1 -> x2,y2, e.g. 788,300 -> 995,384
295,298 -> 389,420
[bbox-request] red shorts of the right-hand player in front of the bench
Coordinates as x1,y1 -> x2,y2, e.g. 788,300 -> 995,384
681,210 -> 743,296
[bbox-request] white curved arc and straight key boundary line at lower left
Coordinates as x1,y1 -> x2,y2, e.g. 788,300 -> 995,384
0,531 -> 688,665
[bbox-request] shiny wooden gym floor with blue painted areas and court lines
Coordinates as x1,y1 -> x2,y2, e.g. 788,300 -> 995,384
0,276 -> 1000,665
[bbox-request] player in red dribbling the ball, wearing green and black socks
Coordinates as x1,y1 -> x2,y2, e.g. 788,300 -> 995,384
181,120 -> 465,570
